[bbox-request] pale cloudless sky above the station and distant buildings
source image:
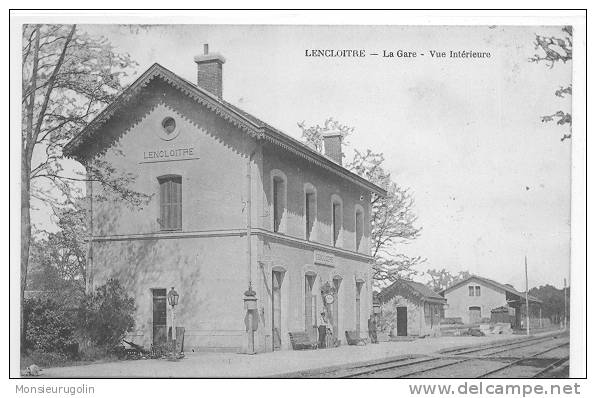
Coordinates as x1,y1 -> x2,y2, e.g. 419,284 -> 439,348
60,25 -> 572,290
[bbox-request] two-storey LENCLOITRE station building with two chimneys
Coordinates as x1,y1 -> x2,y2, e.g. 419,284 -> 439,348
65,45 -> 386,352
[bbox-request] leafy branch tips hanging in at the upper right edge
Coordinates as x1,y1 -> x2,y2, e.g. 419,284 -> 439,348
530,26 -> 573,141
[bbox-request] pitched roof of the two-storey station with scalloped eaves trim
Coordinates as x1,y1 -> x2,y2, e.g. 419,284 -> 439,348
64,63 -> 387,196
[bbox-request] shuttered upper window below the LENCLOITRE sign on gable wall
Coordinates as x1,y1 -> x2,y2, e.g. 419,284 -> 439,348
157,175 -> 182,231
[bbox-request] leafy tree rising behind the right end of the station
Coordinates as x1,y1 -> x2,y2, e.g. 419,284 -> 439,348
298,118 -> 424,287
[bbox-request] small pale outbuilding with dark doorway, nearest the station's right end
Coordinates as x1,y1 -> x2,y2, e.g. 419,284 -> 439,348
378,280 -> 446,336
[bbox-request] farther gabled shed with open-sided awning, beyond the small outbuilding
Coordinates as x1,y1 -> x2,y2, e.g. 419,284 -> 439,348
439,275 -> 541,327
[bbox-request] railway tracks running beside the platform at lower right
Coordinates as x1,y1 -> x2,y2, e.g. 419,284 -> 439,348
304,334 -> 569,378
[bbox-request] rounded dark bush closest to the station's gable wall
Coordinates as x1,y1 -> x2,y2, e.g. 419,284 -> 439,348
79,279 -> 135,350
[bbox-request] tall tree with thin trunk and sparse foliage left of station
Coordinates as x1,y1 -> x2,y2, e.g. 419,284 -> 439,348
21,25 -> 147,342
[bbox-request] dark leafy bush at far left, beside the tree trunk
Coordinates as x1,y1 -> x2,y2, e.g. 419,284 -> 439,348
23,298 -> 77,357
